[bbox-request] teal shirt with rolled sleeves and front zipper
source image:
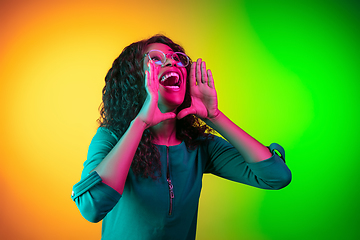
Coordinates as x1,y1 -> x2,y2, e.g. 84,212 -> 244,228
72,128 -> 291,240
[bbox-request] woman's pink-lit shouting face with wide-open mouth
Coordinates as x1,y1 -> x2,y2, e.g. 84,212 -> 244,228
144,43 -> 187,112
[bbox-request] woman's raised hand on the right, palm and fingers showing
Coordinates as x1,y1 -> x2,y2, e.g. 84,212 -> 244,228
177,58 -> 219,120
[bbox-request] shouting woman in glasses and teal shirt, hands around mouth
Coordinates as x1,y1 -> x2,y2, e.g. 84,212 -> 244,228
72,35 -> 291,240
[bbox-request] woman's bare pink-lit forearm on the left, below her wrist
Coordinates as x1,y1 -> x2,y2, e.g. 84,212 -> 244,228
93,118 -> 145,194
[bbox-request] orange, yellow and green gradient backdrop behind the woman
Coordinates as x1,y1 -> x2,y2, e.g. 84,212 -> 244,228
0,0 -> 360,240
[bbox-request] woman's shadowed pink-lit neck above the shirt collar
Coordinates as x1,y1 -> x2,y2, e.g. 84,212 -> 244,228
151,119 -> 181,146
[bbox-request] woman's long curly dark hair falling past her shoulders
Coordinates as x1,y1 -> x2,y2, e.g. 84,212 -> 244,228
98,35 -> 212,179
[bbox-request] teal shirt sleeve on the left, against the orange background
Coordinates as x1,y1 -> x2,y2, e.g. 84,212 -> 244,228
71,128 -> 121,222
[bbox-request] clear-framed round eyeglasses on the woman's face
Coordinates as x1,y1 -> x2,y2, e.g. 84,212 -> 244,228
145,49 -> 190,67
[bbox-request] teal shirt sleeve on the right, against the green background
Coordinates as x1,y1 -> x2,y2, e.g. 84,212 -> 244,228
205,136 -> 291,189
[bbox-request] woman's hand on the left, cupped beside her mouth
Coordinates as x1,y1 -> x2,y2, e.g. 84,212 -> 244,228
137,61 -> 176,128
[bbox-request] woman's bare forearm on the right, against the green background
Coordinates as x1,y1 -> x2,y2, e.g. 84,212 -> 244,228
205,111 -> 272,163
